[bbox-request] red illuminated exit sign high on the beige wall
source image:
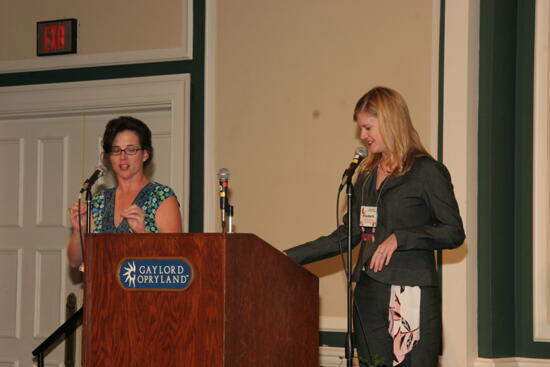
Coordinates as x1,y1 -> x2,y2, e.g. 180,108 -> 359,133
36,19 -> 77,56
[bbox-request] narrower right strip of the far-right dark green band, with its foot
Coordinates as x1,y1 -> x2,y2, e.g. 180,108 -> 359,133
514,0 -> 550,358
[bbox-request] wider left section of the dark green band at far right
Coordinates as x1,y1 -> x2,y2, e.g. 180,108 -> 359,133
478,0 -> 517,358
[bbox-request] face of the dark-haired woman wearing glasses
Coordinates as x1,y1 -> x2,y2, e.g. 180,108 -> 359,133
109,130 -> 149,180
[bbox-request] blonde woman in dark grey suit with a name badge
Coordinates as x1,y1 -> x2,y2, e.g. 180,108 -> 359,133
286,87 -> 465,367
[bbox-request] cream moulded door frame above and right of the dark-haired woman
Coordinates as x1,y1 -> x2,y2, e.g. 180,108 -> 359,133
0,74 -> 190,232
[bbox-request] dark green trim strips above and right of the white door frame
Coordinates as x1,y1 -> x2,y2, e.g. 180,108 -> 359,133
0,0 -> 206,232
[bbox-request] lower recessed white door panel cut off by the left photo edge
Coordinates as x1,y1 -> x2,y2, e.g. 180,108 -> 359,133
0,249 -> 22,340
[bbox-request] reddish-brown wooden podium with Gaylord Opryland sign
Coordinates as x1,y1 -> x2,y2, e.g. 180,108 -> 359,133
83,233 -> 319,367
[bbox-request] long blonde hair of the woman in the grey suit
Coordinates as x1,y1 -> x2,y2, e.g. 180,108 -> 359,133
353,87 -> 430,176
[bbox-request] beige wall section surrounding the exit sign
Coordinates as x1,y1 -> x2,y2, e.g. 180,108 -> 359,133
0,0 -> 187,61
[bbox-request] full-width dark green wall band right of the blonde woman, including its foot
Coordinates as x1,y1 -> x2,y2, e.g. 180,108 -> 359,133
478,0 -> 550,358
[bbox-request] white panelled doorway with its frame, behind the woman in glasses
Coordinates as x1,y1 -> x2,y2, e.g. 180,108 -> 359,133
0,77 -> 188,367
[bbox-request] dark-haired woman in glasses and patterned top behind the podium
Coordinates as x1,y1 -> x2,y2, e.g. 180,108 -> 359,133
68,116 -> 181,266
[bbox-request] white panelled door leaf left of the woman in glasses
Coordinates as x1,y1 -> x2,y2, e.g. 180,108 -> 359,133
0,117 -> 82,367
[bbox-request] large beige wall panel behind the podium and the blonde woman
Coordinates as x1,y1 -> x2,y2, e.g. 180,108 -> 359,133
216,0 -> 437,318
